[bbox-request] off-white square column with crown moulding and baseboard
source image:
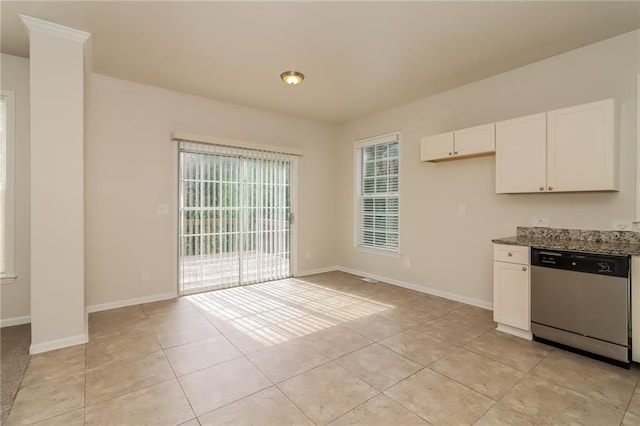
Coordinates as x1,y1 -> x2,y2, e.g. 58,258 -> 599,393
20,15 -> 90,354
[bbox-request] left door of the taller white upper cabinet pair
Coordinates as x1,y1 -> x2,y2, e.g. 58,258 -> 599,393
496,113 -> 547,193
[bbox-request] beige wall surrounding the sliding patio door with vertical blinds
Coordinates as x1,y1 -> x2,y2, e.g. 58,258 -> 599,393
85,72 -> 338,307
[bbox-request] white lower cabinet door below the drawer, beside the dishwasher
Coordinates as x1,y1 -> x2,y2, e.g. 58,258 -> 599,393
493,262 -> 531,331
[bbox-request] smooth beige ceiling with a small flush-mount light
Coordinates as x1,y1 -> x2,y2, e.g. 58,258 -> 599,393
0,0 -> 640,123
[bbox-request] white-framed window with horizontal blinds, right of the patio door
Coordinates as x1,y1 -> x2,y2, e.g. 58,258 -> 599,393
356,133 -> 400,253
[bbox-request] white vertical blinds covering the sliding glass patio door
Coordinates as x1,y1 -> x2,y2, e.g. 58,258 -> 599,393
179,141 -> 293,294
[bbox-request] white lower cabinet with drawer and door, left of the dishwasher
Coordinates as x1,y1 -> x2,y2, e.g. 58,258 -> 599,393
493,244 -> 531,339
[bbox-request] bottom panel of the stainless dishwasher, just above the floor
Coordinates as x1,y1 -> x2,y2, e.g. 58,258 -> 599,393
531,322 -> 629,363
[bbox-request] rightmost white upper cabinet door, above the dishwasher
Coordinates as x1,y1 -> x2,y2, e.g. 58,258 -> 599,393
547,99 -> 616,191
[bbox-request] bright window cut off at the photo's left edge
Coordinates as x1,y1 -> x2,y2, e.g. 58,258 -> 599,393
0,90 -> 15,284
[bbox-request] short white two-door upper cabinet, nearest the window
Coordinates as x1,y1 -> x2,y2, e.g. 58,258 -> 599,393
420,123 -> 495,161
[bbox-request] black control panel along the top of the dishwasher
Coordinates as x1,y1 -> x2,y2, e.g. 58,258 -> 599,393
531,247 -> 629,278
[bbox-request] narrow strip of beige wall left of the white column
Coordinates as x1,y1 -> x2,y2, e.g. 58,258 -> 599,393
0,54 -> 31,322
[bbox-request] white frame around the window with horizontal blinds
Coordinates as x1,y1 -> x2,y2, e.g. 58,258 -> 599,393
353,131 -> 402,257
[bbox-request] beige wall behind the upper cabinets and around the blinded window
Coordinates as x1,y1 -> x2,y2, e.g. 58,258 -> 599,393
336,31 -> 640,306
